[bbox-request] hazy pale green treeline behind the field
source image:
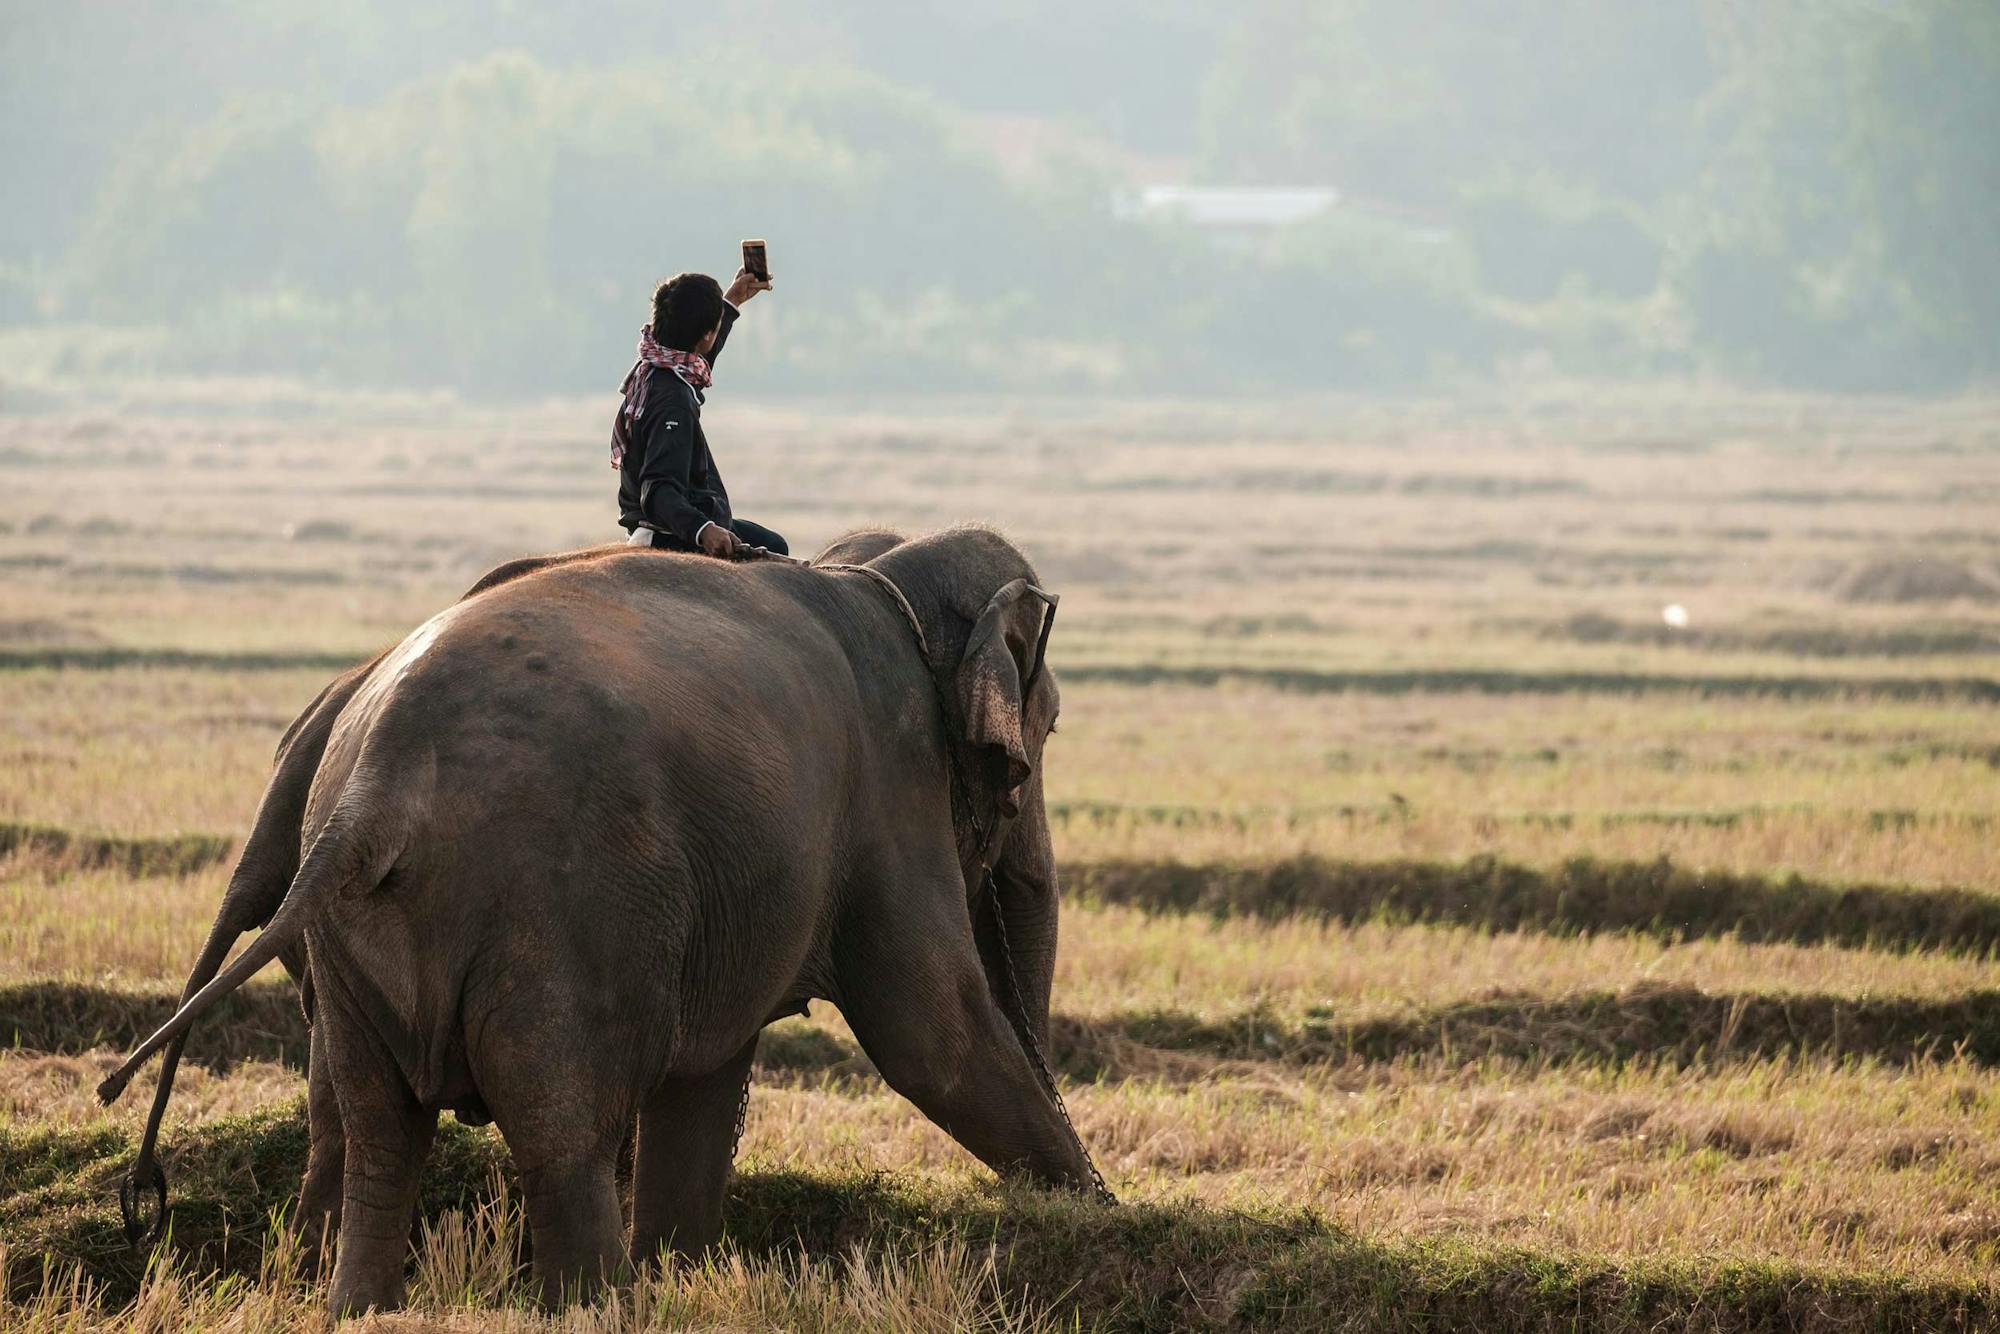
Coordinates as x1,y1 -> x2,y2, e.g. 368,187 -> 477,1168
0,0 -> 2000,394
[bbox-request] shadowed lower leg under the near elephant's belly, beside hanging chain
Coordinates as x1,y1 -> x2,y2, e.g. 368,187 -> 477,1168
632,1038 -> 756,1266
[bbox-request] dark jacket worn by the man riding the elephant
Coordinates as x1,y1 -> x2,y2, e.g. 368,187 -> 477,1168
618,302 -> 736,546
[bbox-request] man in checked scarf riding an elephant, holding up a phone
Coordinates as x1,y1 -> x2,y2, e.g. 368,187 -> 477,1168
612,268 -> 790,560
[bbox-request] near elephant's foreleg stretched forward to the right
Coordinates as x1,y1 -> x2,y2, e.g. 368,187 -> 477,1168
838,886 -> 1090,1188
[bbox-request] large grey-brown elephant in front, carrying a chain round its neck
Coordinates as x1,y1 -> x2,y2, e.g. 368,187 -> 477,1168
100,528 -> 1108,1312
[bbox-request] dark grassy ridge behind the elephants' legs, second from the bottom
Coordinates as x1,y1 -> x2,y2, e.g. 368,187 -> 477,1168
11,982 -> 2000,1080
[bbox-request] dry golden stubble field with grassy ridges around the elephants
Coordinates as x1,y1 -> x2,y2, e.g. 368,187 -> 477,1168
0,386 -> 2000,1330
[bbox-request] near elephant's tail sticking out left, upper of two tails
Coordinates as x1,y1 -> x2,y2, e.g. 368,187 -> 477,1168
98,784 -> 402,1104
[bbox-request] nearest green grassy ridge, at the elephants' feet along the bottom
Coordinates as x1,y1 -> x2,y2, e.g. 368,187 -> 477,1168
0,1104 -> 2000,1332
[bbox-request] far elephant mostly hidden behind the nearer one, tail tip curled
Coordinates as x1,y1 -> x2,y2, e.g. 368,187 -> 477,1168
120,528 -> 902,1266
